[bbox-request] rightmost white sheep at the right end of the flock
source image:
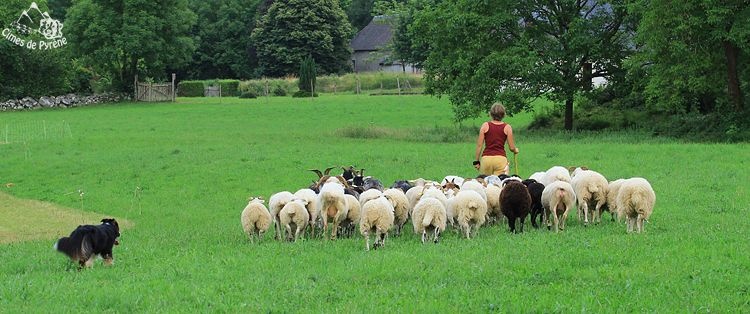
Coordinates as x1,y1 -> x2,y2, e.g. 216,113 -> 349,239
616,178 -> 656,233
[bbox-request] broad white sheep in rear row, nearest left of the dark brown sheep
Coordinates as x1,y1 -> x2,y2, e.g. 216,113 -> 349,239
446,189 -> 487,239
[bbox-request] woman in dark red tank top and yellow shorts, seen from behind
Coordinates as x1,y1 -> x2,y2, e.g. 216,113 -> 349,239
474,103 -> 518,175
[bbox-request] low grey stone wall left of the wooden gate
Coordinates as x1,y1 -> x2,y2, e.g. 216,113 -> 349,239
0,93 -> 131,111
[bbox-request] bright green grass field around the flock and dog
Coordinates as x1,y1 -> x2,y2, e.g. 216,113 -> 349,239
0,95 -> 750,313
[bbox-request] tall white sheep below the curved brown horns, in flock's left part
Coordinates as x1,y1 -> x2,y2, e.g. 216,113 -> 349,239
318,177 -> 348,240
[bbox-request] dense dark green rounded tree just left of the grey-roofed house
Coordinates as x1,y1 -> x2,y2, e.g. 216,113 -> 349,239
252,0 -> 352,77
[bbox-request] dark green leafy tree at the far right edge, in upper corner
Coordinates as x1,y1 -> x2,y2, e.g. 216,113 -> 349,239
631,0 -> 750,114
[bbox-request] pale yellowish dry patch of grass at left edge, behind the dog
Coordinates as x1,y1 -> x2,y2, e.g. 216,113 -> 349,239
0,192 -> 134,244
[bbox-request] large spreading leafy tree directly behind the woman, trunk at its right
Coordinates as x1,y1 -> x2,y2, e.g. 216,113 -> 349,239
414,0 -> 631,130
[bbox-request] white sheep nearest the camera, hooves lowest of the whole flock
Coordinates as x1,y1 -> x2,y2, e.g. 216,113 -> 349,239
359,195 -> 395,251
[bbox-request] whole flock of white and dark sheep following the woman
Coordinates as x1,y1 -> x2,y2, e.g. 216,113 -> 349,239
241,166 -> 656,250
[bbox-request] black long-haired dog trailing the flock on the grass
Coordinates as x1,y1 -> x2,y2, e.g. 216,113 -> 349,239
55,219 -> 120,267
